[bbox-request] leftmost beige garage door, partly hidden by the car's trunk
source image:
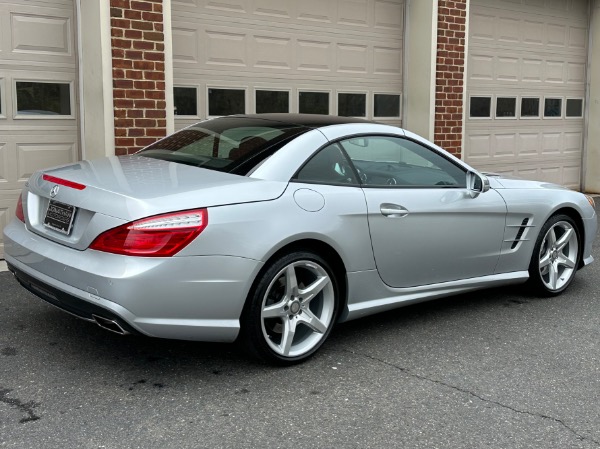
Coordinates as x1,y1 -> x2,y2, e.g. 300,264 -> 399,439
0,0 -> 78,258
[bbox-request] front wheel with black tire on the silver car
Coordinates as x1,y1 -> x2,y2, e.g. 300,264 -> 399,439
529,214 -> 581,296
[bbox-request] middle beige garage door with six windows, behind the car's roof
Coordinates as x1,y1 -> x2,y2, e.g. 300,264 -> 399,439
172,0 -> 404,128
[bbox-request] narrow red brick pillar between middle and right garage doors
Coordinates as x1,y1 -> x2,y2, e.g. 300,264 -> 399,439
434,0 -> 468,157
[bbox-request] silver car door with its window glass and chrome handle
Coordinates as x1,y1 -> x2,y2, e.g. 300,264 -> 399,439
339,136 -> 506,288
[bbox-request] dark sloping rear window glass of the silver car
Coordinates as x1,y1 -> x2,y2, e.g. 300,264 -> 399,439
138,117 -> 309,174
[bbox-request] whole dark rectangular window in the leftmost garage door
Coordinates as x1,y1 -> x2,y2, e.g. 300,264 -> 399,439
15,81 -> 71,118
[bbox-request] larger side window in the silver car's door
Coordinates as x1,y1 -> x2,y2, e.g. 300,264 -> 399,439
339,136 -> 466,187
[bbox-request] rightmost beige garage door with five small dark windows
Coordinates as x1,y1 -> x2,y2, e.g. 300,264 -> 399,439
465,0 -> 589,189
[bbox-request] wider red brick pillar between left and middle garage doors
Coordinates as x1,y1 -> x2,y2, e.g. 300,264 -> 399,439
110,0 -> 167,155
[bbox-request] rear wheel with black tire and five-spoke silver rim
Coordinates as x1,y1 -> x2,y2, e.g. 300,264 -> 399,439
239,251 -> 340,365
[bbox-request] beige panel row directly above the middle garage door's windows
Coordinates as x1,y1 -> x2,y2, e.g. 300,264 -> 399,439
173,22 -> 402,79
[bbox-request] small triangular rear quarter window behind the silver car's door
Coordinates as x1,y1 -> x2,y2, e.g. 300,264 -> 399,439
294,143 -> 358,185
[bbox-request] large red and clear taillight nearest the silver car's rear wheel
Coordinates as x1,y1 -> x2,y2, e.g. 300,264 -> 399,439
90,209 -> 208,257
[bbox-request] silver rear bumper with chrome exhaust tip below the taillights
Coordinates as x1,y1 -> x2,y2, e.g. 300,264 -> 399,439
4,221 -> 262,342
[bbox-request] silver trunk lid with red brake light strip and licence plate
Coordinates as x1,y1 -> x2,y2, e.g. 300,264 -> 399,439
23,155 -> 286,250
